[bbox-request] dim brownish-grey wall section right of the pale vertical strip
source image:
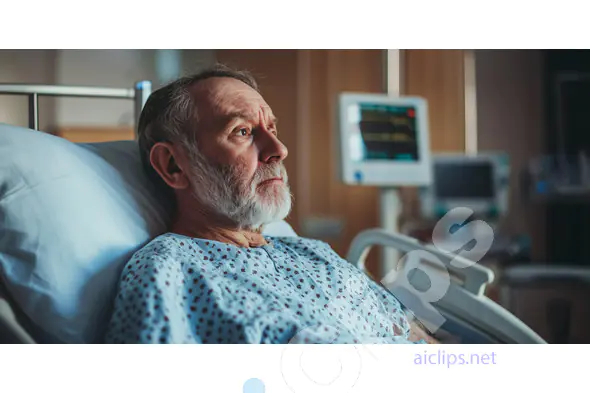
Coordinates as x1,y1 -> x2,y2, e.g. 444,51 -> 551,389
475,50 -> 545,259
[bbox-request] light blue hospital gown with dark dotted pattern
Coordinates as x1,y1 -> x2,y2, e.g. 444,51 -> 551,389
105,233 -> 420,344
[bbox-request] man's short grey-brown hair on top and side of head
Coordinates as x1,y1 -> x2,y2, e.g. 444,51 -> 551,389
137,64 -> 259,180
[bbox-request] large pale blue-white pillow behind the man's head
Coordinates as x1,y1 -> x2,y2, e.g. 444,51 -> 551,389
0,123 -> 297,343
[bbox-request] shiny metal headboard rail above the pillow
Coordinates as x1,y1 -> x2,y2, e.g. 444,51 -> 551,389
0,81 -> 152,130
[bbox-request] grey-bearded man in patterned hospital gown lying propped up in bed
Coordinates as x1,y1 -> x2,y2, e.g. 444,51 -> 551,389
106,66 -> 434,343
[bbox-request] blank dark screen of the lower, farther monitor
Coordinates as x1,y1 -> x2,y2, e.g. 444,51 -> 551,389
434,162 -> 496,199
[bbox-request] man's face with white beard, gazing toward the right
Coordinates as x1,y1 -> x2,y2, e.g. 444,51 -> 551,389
185,78 -> 291,229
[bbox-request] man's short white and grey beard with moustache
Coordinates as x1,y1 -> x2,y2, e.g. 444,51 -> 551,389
189,146 -> 291,230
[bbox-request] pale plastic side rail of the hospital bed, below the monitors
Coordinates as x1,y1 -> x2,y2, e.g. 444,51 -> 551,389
347,229 -> 545,344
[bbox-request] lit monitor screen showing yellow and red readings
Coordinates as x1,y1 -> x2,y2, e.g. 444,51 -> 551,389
356,103 -> 420,161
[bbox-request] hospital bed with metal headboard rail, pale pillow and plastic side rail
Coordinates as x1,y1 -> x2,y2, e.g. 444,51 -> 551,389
0,82 -> 544,343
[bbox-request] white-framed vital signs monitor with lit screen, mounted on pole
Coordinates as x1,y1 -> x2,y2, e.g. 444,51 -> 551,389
337,93 -> 432,187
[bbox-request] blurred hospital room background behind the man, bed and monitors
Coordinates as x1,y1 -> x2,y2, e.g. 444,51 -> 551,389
0,50 -> 590,343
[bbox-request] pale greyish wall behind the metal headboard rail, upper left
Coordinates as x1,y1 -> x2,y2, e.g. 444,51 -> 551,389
0,50 -> 215,130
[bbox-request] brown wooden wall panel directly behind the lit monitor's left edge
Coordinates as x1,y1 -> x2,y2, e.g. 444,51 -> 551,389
299,50 -> 384,271
